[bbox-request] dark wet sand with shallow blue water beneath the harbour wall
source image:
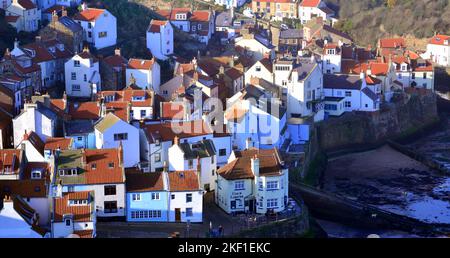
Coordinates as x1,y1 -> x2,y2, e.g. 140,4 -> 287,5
323,145 -> 450,223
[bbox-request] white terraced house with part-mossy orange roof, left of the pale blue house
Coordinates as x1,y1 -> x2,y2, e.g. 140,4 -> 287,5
53,148 -> 126,217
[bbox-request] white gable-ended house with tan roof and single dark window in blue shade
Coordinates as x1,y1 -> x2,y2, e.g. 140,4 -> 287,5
94,113 -> 140,168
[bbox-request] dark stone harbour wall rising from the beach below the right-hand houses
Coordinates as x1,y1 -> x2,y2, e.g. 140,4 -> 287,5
315,90 -> 439,153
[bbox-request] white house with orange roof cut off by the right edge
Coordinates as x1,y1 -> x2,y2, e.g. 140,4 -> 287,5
424,35 -> 450,66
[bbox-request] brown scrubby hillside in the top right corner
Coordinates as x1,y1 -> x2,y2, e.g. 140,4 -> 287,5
327,0 -> 450,45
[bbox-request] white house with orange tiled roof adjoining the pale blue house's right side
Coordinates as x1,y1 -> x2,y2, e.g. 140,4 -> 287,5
168,171 -> 203,222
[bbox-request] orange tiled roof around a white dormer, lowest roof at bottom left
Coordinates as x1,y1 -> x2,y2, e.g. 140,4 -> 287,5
54,191 -> 94,222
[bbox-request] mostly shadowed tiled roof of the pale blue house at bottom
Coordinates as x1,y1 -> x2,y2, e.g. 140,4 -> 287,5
125,169 -> 164,192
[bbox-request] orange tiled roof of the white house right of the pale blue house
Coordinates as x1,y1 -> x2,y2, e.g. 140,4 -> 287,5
168,171 -> 200,192
